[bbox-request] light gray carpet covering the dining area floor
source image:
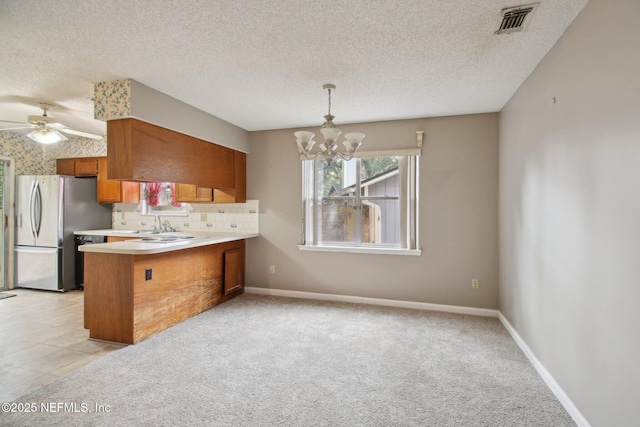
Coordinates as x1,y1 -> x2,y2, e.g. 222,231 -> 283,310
0,294 -> 575,426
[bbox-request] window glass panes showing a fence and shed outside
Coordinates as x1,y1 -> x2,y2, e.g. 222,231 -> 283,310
303,152 -> 417,249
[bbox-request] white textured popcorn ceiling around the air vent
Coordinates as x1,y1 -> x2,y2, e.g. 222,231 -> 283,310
0,0 -> 588,134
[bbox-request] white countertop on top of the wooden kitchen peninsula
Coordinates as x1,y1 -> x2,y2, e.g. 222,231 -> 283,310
74,229 -> 259,255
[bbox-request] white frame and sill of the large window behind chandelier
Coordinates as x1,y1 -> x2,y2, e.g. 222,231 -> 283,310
298,148 -> 421,256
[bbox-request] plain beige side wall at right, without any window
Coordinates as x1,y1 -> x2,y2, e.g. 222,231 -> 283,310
500,0 -> 640,426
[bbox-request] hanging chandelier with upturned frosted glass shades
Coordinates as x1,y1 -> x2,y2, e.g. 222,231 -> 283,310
293,83 -> 364,162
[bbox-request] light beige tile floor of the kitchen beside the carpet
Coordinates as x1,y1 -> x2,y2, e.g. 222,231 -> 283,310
0,289 -> 122,403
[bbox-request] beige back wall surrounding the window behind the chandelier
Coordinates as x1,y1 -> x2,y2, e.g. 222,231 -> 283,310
247,114 -> 498,309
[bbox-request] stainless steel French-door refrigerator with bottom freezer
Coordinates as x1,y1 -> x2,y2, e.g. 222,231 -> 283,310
15,175 -> 111,292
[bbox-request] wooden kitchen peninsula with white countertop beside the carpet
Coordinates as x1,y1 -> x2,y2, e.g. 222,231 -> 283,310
76,230 -> 258,344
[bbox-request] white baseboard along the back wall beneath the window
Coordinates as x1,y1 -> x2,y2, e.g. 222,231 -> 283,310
244,286 -> 499,317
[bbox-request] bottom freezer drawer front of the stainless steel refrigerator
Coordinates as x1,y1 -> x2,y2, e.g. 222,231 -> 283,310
15,246 -> 62,291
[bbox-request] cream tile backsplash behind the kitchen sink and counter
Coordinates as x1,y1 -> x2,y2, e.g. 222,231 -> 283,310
112,200 -> 260,233
